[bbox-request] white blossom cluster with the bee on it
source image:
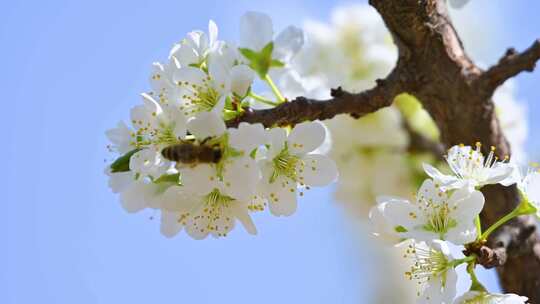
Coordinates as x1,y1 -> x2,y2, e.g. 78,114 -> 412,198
106,12 -> 337,239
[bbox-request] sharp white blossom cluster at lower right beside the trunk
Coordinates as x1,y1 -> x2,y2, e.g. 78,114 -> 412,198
370,143 -> 540,304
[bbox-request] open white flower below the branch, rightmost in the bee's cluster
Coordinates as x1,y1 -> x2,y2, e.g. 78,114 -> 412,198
259,122 -> 338,216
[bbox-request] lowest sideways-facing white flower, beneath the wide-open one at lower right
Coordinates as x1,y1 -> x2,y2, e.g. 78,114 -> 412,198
396,240 -> 457,304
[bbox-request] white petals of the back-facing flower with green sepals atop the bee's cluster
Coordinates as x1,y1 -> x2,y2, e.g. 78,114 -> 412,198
239,12 -> 304,63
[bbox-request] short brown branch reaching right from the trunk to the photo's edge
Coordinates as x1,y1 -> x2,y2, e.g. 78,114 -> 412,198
478,39 -> 540,96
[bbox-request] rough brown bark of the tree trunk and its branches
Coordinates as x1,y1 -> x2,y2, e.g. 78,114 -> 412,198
228,0 -> 540,303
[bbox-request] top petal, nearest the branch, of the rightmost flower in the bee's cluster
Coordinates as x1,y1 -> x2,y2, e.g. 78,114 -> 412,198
287,121 -> 326,154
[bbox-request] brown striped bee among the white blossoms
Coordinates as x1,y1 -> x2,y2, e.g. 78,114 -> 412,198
161,140 -> 222,165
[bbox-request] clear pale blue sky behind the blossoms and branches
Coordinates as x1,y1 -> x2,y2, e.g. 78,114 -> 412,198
0,0 -> 540,304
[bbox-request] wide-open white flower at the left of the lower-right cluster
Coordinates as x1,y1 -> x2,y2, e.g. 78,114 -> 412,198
379,179 -> 484,244
